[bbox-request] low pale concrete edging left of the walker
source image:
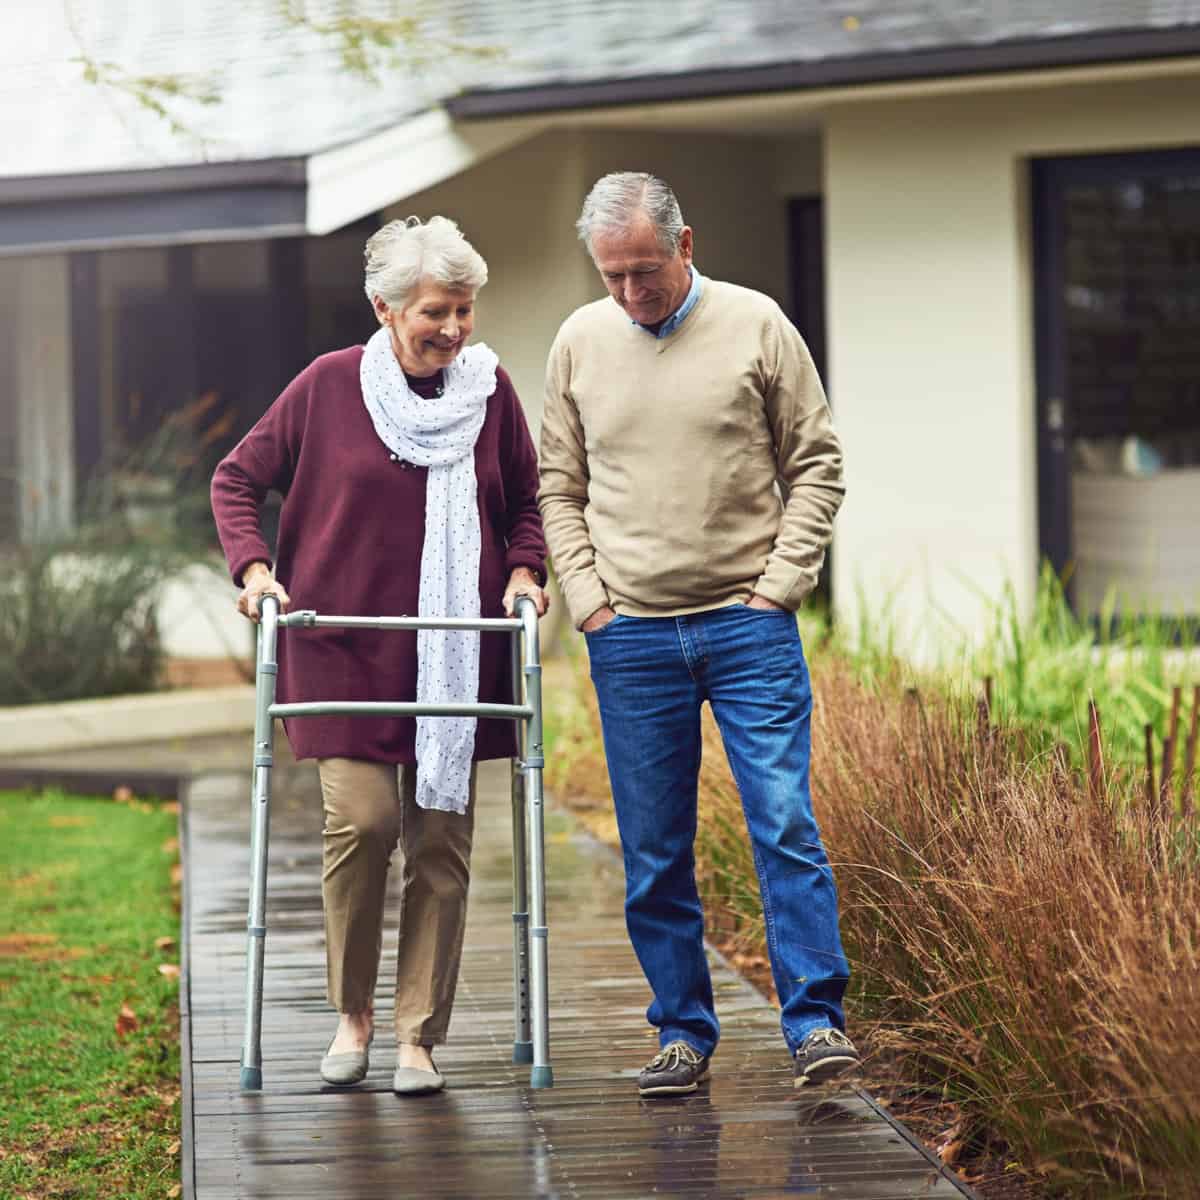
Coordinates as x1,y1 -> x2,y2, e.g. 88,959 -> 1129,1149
0,684 -> 254,757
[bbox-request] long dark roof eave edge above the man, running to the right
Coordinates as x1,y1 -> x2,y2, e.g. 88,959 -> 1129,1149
445,25 -> 1200,120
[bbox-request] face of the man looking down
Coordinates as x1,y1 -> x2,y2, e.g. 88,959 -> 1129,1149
592,214 -> 691,325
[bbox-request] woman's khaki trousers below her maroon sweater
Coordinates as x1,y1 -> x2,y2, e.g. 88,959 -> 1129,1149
317,758 -> 475,1046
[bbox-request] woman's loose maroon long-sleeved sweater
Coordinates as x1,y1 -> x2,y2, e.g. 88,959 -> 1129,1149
212,346 -> 546,763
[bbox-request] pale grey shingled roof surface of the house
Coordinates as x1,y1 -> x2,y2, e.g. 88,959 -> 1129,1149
7,0 -> 1200,176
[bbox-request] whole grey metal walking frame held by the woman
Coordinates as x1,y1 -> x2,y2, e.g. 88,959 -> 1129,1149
241,595 -> 554,1092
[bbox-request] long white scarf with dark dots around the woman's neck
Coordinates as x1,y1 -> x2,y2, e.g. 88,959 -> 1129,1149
359,329 -> 499,812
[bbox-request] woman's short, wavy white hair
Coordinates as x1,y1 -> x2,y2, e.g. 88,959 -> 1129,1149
364,217 -> 487,308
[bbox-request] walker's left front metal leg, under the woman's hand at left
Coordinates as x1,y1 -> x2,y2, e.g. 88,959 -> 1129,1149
241,596 -> 278,1092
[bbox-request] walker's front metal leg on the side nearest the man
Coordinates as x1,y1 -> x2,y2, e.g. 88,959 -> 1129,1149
522,605 -> 554,1087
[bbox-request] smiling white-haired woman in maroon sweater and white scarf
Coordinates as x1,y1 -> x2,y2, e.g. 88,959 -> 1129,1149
212,217 -> 546,1093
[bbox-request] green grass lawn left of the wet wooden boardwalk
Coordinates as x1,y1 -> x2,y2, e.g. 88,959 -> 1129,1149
0,792 -> 180,1200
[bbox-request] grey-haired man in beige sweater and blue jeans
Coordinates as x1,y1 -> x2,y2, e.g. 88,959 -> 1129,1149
539,173 -> 858,1097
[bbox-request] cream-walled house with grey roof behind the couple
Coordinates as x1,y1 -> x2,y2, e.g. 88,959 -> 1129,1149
0,0 -> 1200,662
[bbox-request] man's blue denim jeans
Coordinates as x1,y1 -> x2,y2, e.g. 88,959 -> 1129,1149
587,604 -> 850,1055
